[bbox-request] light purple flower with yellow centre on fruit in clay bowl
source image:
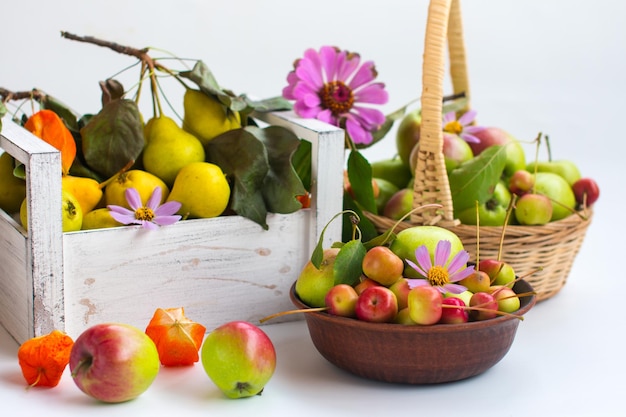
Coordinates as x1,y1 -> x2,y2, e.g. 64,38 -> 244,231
406,240 -> 474,294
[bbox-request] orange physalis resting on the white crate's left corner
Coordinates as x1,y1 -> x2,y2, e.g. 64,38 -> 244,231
24,109 -> 76,175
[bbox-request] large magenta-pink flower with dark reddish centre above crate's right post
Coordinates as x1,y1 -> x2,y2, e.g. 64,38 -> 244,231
283,46 -> 389,145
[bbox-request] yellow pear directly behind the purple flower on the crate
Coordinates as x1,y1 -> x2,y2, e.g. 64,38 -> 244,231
104,169 -> 169,208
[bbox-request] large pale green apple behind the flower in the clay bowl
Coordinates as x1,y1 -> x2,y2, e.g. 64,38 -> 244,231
390,225 -> 463,278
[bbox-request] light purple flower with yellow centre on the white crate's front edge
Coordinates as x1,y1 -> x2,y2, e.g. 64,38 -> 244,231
107,187 -> 181,230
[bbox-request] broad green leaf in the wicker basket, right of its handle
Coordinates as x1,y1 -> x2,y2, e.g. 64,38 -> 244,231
448,145 -> 506,212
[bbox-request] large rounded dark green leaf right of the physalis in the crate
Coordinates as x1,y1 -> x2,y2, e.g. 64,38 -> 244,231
80,99 -> 145,178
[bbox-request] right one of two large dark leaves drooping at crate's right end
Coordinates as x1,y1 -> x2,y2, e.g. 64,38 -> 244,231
251,126 -> 306,214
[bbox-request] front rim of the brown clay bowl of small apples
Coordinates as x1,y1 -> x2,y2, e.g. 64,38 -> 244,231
289,279 -> 537,334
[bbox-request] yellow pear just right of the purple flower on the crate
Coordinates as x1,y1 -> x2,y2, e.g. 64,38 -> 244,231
168,162 -> 230,218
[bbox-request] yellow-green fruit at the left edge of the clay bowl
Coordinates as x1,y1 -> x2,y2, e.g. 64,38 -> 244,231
295,248 -> 339,307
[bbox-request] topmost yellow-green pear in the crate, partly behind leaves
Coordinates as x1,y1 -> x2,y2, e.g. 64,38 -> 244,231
183,88 -> 241,145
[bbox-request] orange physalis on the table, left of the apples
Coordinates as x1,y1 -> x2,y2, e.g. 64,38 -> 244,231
17,330 -> 74,387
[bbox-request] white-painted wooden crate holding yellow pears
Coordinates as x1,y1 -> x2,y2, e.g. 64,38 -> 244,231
0,112 -> 344,343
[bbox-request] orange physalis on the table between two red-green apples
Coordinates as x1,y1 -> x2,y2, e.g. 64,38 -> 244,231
146,307 -> 206,366
